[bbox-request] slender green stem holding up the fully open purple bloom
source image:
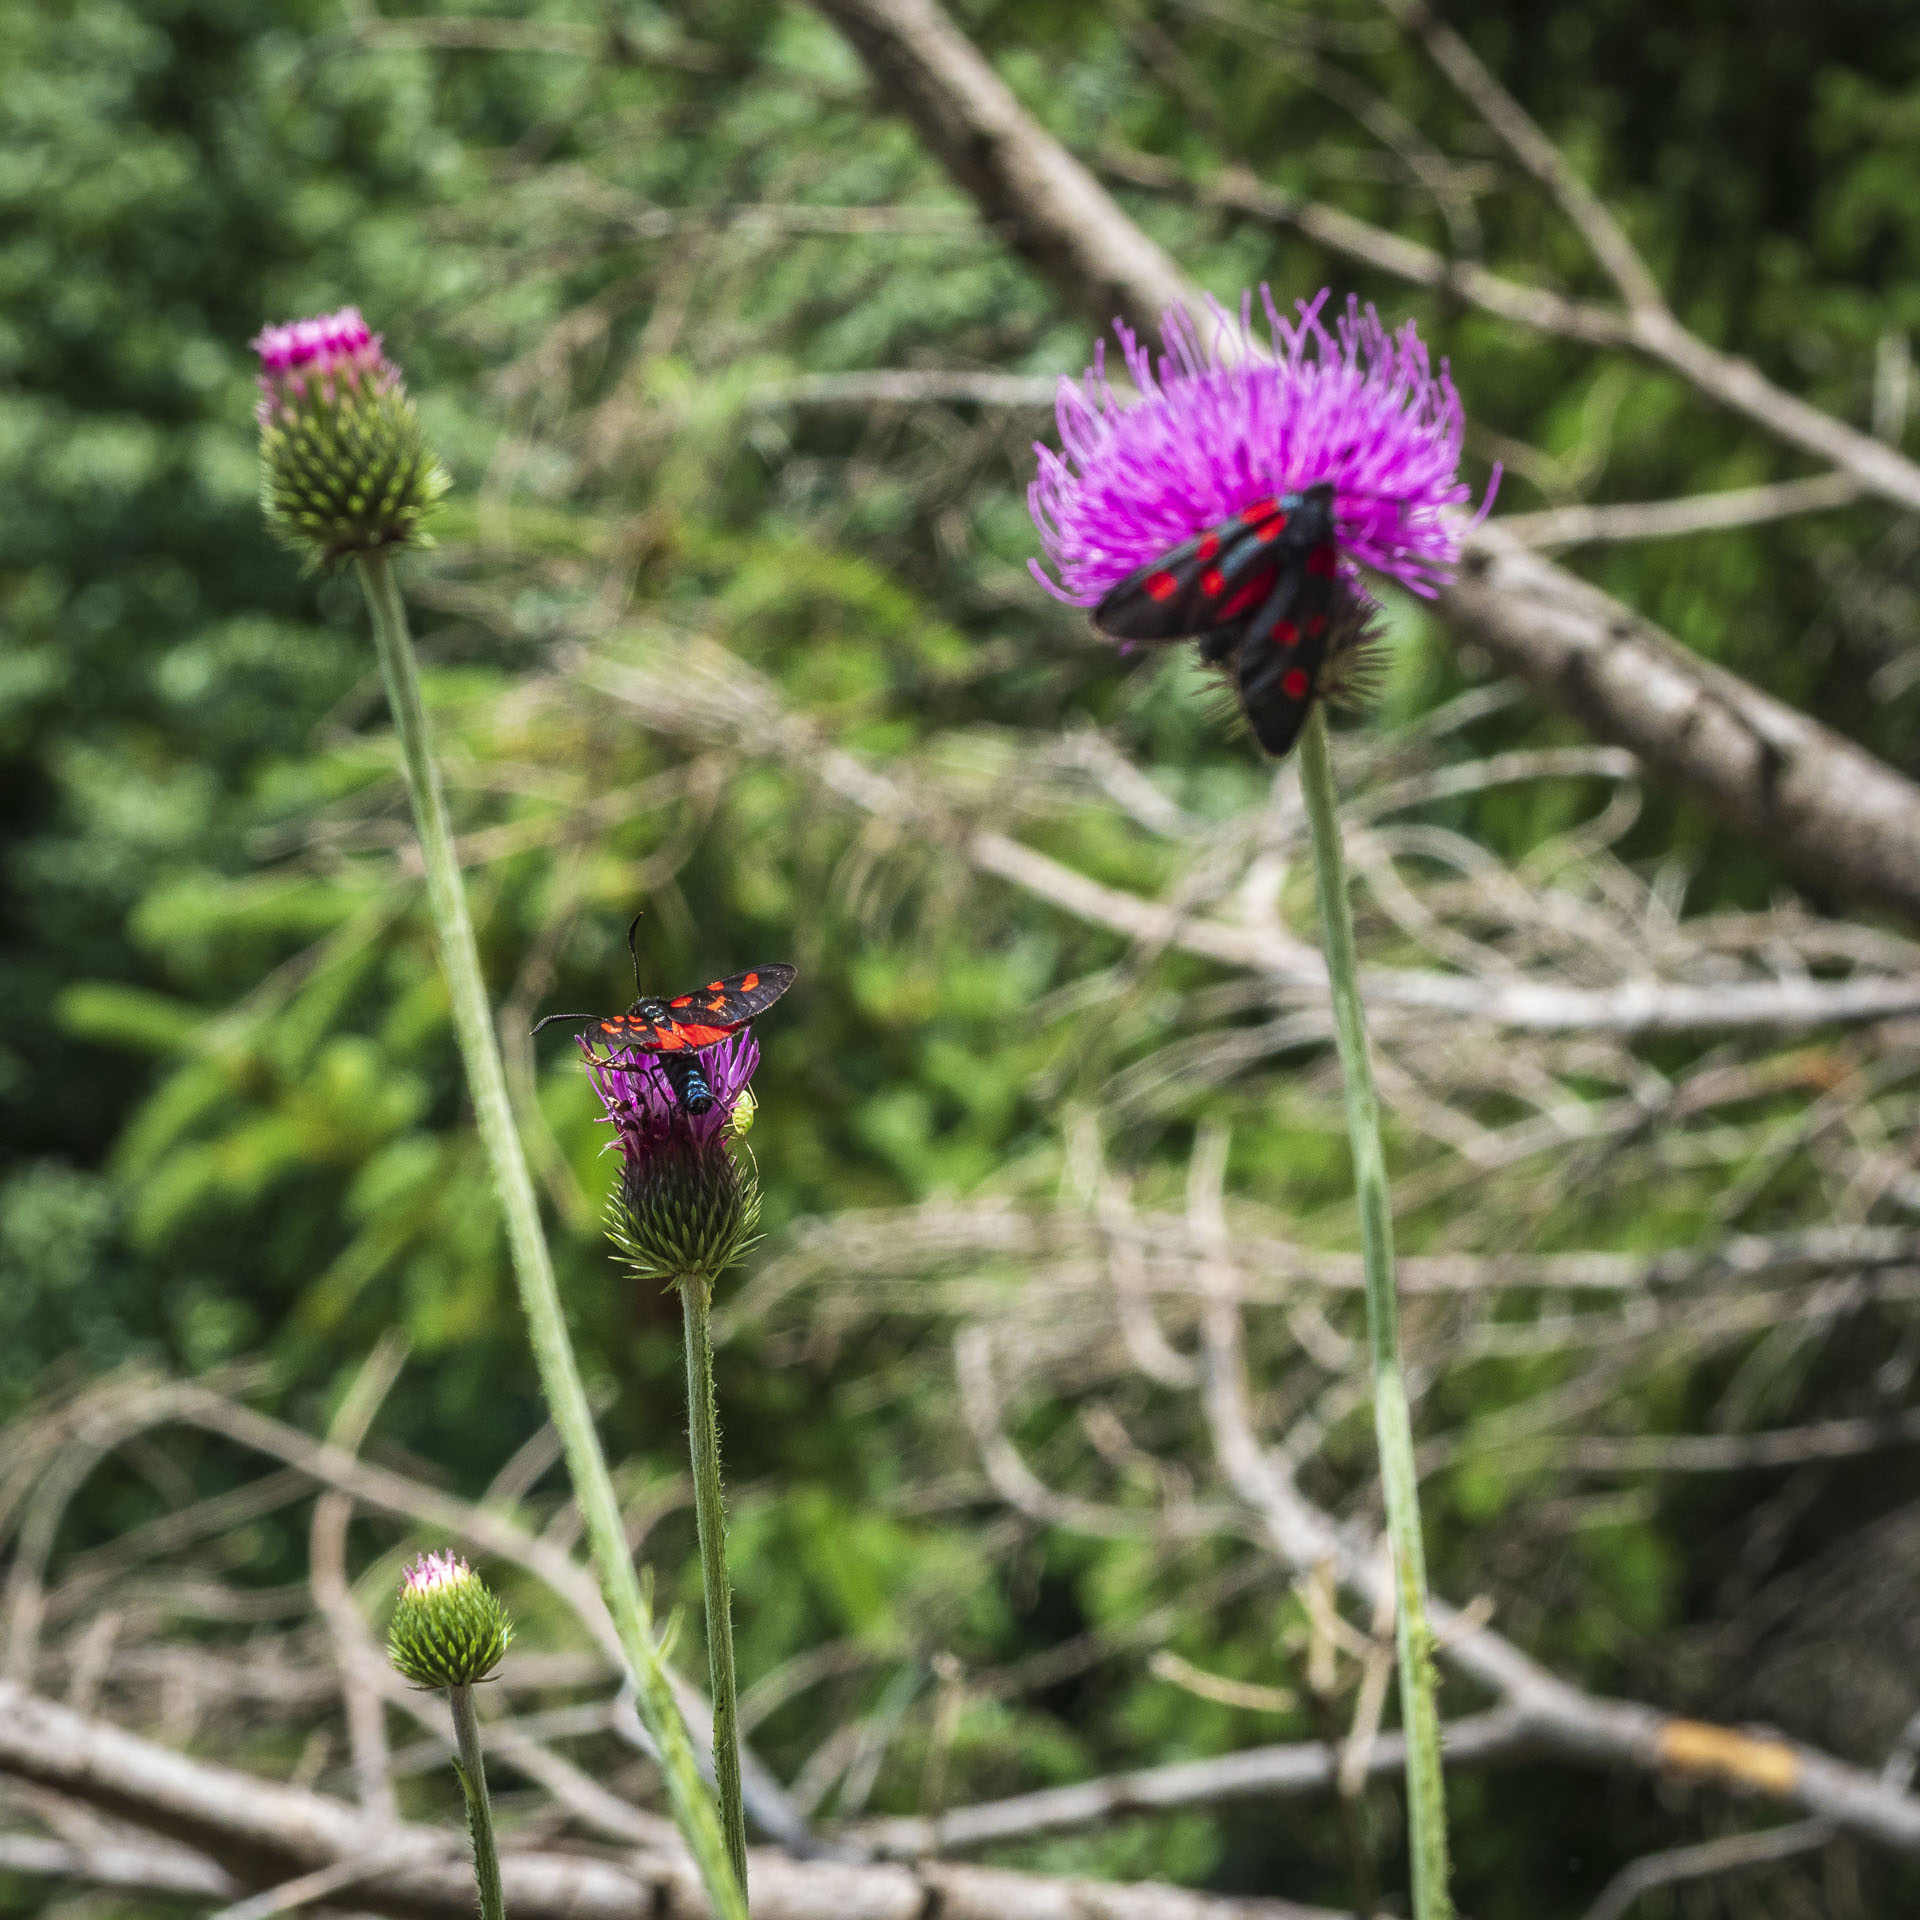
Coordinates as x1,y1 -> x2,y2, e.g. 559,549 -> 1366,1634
1298,705 -> 1453,1920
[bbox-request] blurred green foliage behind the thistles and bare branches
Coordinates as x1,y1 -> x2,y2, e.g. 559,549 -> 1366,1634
11,0 -> 1920,1916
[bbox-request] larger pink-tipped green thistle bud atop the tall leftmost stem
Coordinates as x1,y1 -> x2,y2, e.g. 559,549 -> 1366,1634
253,307 -> 449,563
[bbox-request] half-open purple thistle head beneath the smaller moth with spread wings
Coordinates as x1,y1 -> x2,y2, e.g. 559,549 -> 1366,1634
580,1027 -> 760,1284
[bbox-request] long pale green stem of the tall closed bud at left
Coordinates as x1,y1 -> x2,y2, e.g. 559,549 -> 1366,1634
359,553 -> 747,1920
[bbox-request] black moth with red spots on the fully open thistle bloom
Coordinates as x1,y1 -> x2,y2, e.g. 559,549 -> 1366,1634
1092,482 -> 1359,758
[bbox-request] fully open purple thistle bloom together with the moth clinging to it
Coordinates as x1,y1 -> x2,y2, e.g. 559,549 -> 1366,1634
1027,288 -> 1498,758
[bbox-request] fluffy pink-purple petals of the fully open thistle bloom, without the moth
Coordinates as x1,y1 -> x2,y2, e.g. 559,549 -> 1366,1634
1027,288 -> 1492,607
